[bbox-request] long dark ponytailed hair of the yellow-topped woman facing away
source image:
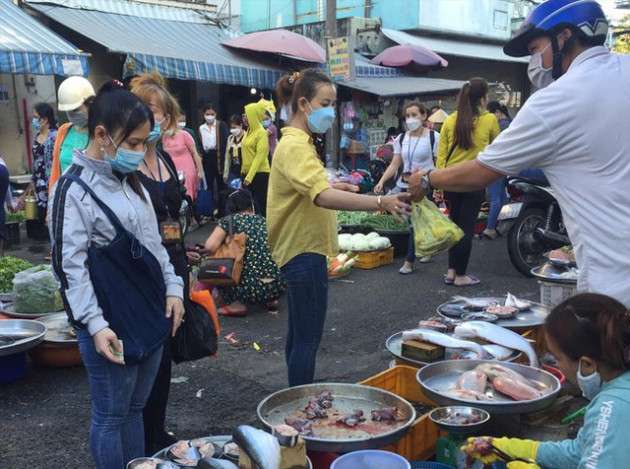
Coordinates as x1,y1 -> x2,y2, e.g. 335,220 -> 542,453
455,77 -> 490,150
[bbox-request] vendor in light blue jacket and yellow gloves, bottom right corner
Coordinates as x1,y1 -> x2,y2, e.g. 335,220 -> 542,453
462,293 -> 630,469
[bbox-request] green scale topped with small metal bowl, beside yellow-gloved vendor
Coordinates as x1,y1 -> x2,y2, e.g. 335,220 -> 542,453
429,406 -> 490,469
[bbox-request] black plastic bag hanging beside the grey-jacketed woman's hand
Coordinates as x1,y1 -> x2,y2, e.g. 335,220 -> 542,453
171,300 -> 219,363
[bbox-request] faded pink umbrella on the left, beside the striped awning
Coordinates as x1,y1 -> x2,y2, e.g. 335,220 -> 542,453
223,29 -> 326,63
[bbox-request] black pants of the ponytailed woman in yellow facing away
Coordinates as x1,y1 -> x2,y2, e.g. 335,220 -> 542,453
444,190 -> 486,275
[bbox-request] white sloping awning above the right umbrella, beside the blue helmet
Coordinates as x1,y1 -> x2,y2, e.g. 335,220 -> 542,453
382,28 -> 528,63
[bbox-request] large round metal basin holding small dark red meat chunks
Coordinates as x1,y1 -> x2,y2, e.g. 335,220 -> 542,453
257,383 -> 416,453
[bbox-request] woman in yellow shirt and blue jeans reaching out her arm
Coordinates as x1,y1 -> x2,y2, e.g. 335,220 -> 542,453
267,69 -> 411,386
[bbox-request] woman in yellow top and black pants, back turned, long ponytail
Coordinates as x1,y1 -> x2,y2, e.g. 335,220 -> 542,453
435,77 -> 500,287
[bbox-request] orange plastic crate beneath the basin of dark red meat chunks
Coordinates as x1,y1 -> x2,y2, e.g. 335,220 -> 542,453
359,365 -> 443,461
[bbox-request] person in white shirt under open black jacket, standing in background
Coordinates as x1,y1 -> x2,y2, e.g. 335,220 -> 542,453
199,105 -> 229,217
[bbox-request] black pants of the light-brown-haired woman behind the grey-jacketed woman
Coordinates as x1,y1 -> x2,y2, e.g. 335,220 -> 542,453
142,245 -> 190,455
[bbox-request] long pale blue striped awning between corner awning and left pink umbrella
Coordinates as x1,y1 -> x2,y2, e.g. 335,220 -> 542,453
28,0 -> 286,88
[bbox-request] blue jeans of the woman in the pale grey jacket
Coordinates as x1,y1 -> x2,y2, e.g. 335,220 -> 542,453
77,329 -> 162,469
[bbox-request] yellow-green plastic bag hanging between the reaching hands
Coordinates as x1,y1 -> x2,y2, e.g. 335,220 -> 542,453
411,197 -> 464,257
